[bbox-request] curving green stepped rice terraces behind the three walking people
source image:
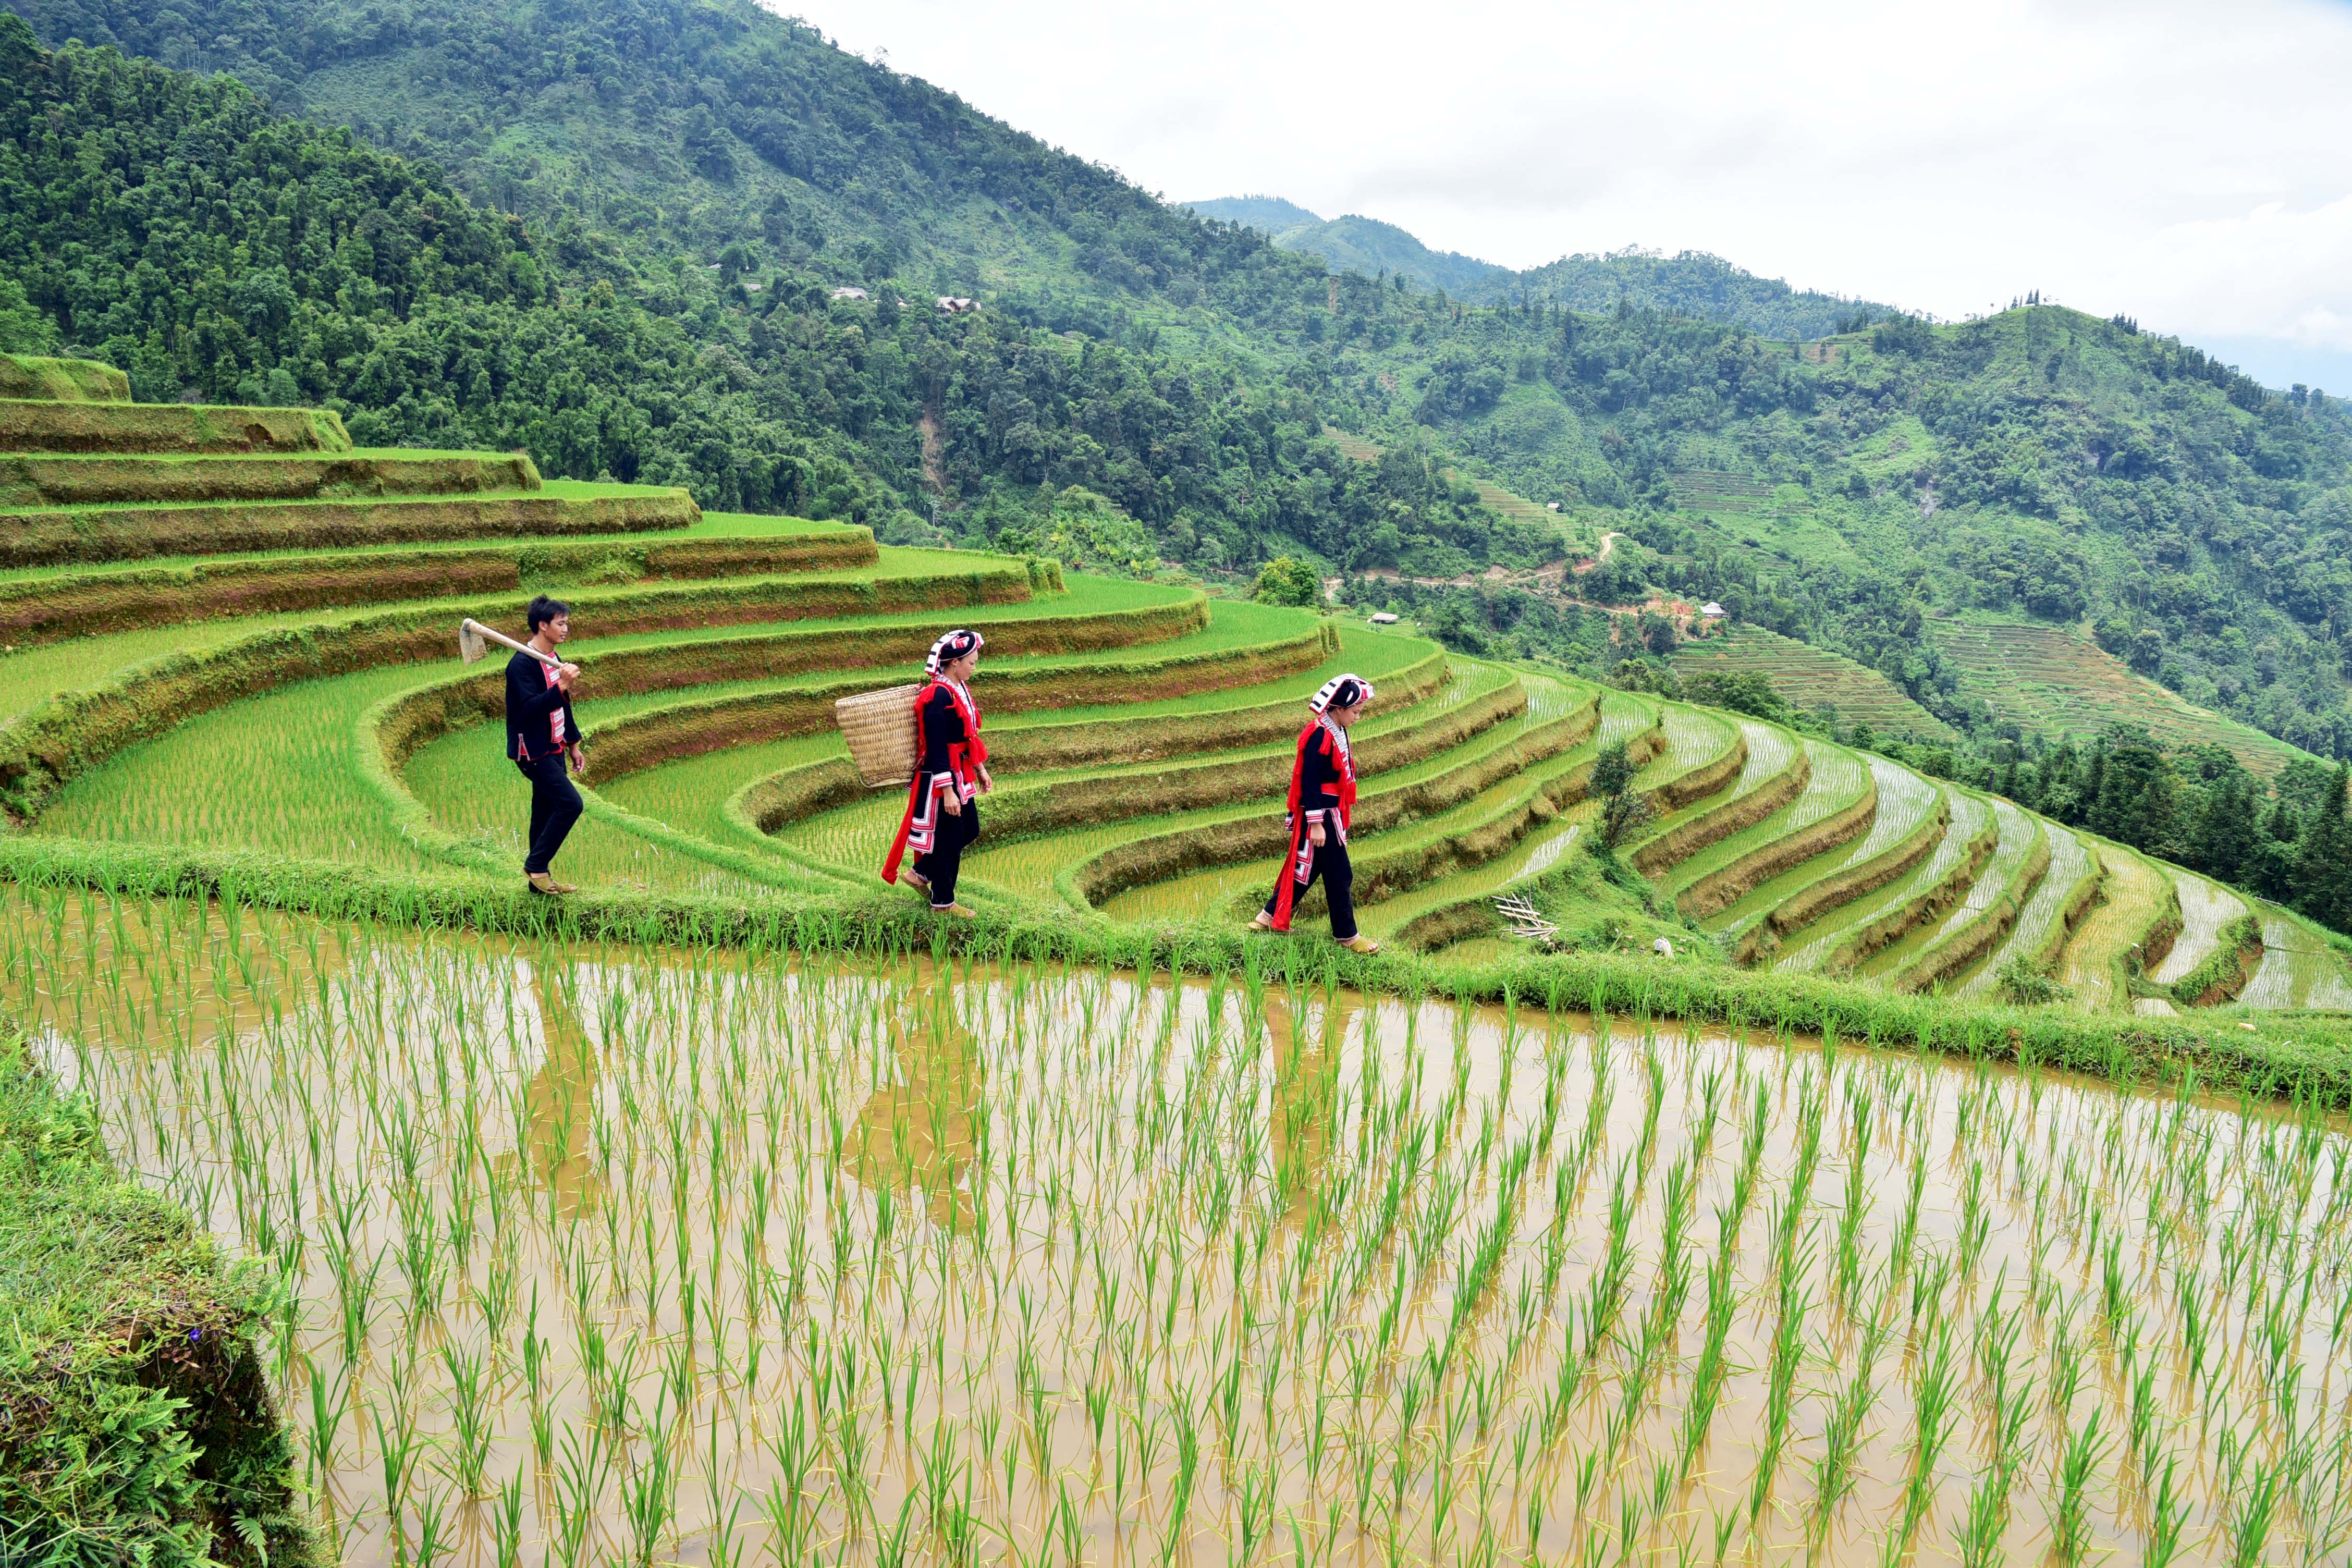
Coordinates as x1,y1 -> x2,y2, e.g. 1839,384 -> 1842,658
0,359 -> 2333,1053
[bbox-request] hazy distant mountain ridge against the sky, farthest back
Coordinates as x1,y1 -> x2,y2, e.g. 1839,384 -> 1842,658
1185,195 -> 1901,338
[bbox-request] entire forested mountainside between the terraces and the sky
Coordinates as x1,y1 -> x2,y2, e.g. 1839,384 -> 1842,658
14,0 -> 2352,776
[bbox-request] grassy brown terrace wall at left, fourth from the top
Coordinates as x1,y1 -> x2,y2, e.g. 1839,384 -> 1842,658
0,489 -> 703,567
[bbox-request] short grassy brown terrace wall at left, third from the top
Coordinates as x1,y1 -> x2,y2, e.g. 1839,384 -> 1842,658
0,451 -> 538,506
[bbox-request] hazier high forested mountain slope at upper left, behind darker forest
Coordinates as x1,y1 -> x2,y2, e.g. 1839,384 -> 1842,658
7,0 -> 1317,315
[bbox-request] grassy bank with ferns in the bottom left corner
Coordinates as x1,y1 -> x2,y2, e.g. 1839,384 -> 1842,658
0,1027 -> 322,1568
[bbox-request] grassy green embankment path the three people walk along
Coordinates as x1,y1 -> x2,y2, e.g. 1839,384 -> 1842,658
18,837 -> 2352,1110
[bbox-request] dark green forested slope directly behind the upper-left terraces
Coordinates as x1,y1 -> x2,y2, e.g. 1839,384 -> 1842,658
0,14 -> 1496,569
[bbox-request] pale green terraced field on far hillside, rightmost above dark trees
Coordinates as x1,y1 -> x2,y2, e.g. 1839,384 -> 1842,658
1929,621 -> 2302,778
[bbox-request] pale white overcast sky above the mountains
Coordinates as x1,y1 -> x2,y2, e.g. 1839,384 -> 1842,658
771,0 -> 2352,393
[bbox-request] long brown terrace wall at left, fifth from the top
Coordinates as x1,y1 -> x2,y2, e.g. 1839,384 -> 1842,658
0,529 -> 875,646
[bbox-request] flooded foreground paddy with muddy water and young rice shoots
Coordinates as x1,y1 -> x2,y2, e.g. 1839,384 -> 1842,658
0,893 -> 2352,1568
